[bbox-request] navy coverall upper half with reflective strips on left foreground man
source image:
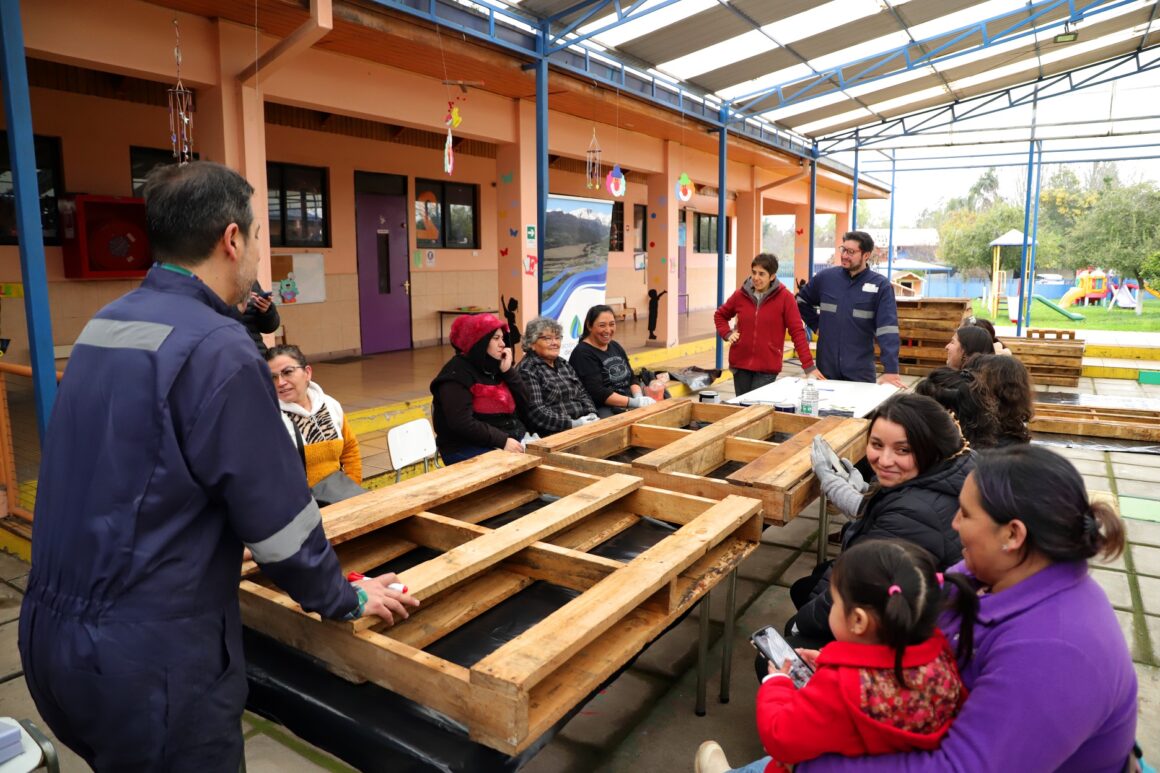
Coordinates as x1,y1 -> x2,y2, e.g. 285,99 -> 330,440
28,267 -> 357,622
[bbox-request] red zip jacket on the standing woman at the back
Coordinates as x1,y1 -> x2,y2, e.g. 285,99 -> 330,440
713,279 -> 813,373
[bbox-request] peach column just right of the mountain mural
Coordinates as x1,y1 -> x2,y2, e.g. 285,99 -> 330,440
647,142 -> 677,346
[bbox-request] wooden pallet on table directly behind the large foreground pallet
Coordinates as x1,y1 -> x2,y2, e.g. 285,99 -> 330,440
528,398 -> 868,525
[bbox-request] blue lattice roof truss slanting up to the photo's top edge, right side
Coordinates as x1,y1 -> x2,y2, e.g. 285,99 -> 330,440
732,0 -> 1139,115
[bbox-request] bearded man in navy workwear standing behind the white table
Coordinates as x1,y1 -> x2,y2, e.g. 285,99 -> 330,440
797,231 -> 905,389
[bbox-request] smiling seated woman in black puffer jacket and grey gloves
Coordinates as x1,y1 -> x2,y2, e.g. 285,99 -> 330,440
785,392 -> 974,646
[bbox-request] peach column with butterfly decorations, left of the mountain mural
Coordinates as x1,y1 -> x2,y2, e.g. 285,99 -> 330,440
495,100 -> 543,354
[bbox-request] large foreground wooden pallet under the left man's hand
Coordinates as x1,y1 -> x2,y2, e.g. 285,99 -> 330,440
241,451 -> 763,754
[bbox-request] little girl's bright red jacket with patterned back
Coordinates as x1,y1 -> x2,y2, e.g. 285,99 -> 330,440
757,630 -> 966,773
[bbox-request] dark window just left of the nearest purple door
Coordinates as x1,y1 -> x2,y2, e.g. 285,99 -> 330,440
266,161 -> 331,247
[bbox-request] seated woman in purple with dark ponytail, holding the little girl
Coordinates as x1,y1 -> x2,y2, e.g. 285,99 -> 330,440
798,443 -> 1138,773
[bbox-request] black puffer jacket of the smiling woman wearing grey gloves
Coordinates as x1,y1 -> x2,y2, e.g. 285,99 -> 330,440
793,454 -> 974,641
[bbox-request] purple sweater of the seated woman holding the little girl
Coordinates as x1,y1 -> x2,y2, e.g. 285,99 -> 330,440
797,562 -> 1136,773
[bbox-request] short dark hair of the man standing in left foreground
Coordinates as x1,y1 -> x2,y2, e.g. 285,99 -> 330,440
145,161 -> 254,267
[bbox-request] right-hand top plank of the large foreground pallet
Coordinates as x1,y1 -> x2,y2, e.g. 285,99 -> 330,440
471,497 -> 759,691
